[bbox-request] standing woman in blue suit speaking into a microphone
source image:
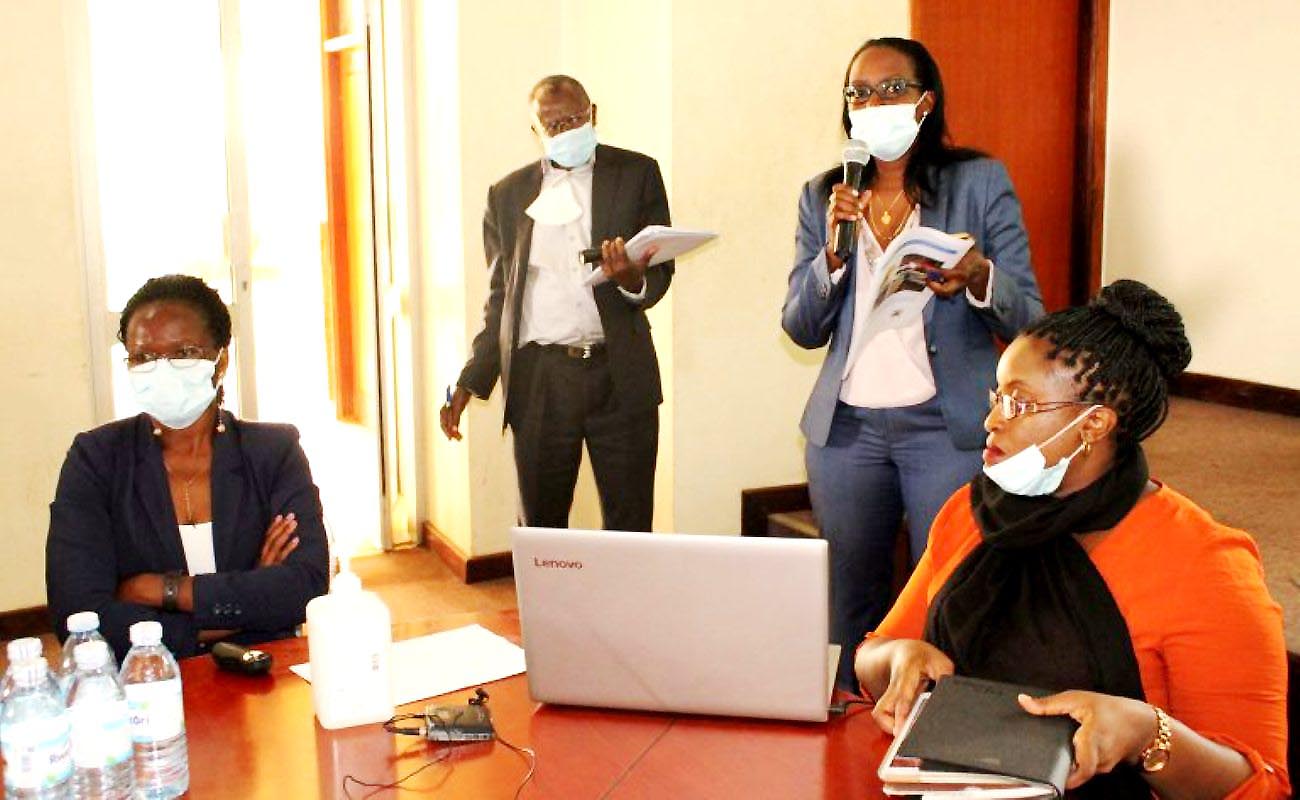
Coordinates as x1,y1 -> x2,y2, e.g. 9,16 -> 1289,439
781,38 -> 1043,688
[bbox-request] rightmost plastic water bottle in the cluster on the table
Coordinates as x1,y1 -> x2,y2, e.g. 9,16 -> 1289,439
122,620 -> 190,800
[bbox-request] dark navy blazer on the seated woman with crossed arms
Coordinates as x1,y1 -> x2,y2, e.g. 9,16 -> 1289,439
46,411 -> 329,658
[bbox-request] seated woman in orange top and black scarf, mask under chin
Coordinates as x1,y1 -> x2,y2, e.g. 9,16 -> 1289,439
855,281 -> 1290,799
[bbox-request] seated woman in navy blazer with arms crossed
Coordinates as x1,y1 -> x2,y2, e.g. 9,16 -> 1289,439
46,276 -> 329,658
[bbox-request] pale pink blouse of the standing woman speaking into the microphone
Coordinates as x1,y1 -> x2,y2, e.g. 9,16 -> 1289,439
831,206 -> 993,408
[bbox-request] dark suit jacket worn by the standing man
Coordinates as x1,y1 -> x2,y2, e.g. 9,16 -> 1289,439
456,144 -> 673,424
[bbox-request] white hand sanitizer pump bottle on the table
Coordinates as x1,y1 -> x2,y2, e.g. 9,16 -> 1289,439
307,558 -> 393,728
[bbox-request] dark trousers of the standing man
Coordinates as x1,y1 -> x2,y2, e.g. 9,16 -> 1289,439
510,345 -> 659,531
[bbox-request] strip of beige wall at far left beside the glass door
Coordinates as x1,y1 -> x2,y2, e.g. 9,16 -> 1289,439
0,3 -> 94,610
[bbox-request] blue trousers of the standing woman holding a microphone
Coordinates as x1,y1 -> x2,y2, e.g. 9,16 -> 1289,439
806,398 -> 980,691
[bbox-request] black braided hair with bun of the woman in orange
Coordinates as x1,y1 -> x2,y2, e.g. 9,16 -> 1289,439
1022,281 -> 1192,446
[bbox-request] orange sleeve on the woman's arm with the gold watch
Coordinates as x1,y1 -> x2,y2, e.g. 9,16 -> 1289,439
1161,517 -> 1290,800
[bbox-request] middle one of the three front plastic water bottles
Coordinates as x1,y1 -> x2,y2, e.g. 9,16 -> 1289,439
68,641 -> 135,800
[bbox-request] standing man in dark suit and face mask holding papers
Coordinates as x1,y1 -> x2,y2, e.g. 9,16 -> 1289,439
441,75 -> 673,531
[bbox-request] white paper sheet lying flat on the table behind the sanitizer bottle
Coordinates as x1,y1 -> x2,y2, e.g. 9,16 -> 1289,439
289,624 -> 524,705
